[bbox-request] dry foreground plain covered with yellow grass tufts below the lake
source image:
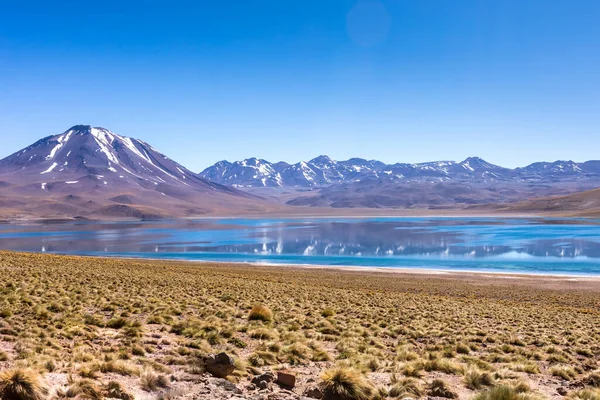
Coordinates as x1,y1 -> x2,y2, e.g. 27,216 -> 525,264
0,252 -> 600,400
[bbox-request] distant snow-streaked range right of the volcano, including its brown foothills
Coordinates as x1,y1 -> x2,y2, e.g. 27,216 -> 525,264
200,156 -> 600,208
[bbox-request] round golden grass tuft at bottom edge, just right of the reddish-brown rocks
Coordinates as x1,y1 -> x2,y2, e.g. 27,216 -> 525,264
321,367 -> 374,400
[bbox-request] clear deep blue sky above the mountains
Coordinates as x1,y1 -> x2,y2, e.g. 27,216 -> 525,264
0,0 -> 600,171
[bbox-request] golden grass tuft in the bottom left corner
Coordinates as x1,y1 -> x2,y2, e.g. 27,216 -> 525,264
0,369 -> 48,400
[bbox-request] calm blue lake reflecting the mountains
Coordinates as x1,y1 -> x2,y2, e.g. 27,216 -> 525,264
0,218 -> 600,275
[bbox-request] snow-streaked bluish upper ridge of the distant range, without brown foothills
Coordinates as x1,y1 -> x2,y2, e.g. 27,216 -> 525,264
200,156 -> 600,188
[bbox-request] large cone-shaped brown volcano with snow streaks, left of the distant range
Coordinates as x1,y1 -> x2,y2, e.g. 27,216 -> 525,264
0,125 -> 264,217
